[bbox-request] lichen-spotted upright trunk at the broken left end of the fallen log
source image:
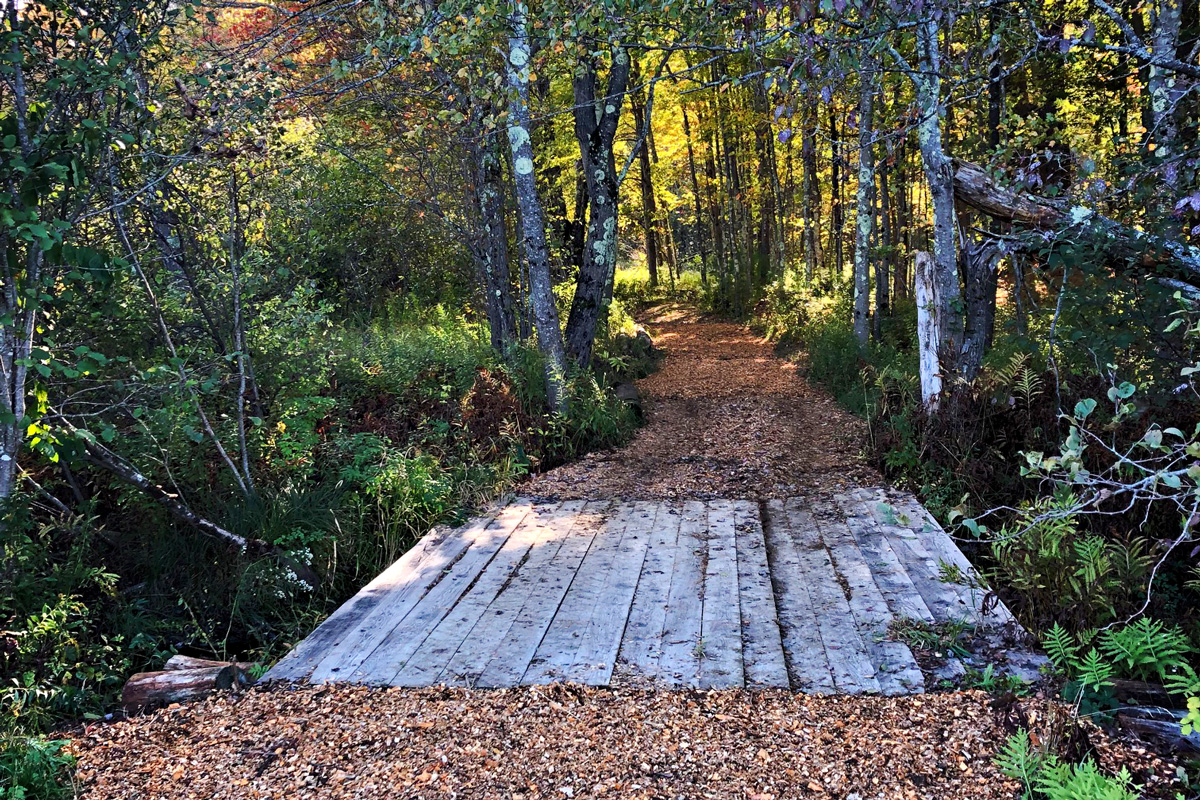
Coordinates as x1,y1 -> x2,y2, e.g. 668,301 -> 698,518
912,17 -> 962,384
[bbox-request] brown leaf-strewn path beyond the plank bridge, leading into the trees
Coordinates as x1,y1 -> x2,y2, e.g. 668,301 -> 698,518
524,305 -> 882,499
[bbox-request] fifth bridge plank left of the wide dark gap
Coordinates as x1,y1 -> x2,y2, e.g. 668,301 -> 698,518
565,501 -> 662,686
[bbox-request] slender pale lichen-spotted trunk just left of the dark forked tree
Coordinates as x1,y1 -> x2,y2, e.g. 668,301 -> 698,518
505,0 -> 566,413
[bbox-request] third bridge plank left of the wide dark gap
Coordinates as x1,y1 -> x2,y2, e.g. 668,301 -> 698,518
658,500 -> 708,687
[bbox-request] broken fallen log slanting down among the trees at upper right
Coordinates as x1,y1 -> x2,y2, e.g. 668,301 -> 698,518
954,158 -> 1200,283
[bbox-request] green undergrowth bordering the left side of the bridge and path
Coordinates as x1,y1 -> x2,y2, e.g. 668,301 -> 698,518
0,308 -> 650,800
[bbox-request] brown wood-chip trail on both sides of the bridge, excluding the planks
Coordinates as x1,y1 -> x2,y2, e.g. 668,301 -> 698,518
73,308 -> 1175,800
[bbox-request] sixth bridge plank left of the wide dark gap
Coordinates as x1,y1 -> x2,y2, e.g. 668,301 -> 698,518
521,503 -> 635,684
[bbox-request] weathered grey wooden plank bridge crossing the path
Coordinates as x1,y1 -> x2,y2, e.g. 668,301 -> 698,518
266,489 -> 1012,694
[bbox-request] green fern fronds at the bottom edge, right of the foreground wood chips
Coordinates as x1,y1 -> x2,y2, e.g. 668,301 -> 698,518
995,729 -> 1139,800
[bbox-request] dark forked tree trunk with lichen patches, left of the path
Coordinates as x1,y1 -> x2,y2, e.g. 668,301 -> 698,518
566,44 -> 646,367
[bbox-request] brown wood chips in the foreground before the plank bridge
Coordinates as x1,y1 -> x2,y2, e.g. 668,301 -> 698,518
74,685 -> 1174,800
